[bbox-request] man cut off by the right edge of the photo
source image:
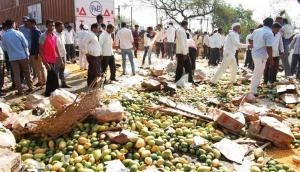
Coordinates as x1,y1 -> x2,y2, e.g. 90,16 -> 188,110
290,34 -> 300,79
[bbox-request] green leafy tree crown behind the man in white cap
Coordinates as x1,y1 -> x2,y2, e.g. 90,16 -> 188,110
212,2 -> 257,38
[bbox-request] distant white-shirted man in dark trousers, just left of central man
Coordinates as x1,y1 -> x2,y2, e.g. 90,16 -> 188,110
166,22 -> 176,60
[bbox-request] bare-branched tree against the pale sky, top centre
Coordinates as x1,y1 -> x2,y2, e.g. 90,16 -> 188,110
141,0 -> 218,23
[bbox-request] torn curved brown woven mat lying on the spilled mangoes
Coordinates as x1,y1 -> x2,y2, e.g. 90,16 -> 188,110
27,77 -> 104,138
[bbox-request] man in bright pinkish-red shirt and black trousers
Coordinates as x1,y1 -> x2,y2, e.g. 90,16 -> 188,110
39,20 -> 60,97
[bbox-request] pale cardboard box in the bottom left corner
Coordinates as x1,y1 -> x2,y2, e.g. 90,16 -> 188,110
0,149 -> 22,172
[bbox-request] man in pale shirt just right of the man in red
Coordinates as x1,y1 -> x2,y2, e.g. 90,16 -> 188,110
55,21 -> 71,88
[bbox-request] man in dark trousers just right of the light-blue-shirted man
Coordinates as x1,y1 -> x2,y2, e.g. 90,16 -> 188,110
264,23 -> 284,84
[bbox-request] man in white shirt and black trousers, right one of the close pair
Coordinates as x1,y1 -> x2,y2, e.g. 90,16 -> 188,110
99,24 -> 116,81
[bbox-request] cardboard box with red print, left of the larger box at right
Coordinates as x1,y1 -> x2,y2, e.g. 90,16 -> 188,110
214,109 -> 245,134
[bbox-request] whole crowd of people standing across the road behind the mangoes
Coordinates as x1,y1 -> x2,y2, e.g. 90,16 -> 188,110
0,15 -> 300,96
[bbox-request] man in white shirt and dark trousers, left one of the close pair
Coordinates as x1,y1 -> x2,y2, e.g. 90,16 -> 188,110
83,23 -> 101,86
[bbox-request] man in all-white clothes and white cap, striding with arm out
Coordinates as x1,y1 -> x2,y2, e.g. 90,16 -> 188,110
211,23 -> 247,84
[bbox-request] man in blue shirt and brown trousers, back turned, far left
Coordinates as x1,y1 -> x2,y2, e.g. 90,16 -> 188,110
2,20 -> 33,95
